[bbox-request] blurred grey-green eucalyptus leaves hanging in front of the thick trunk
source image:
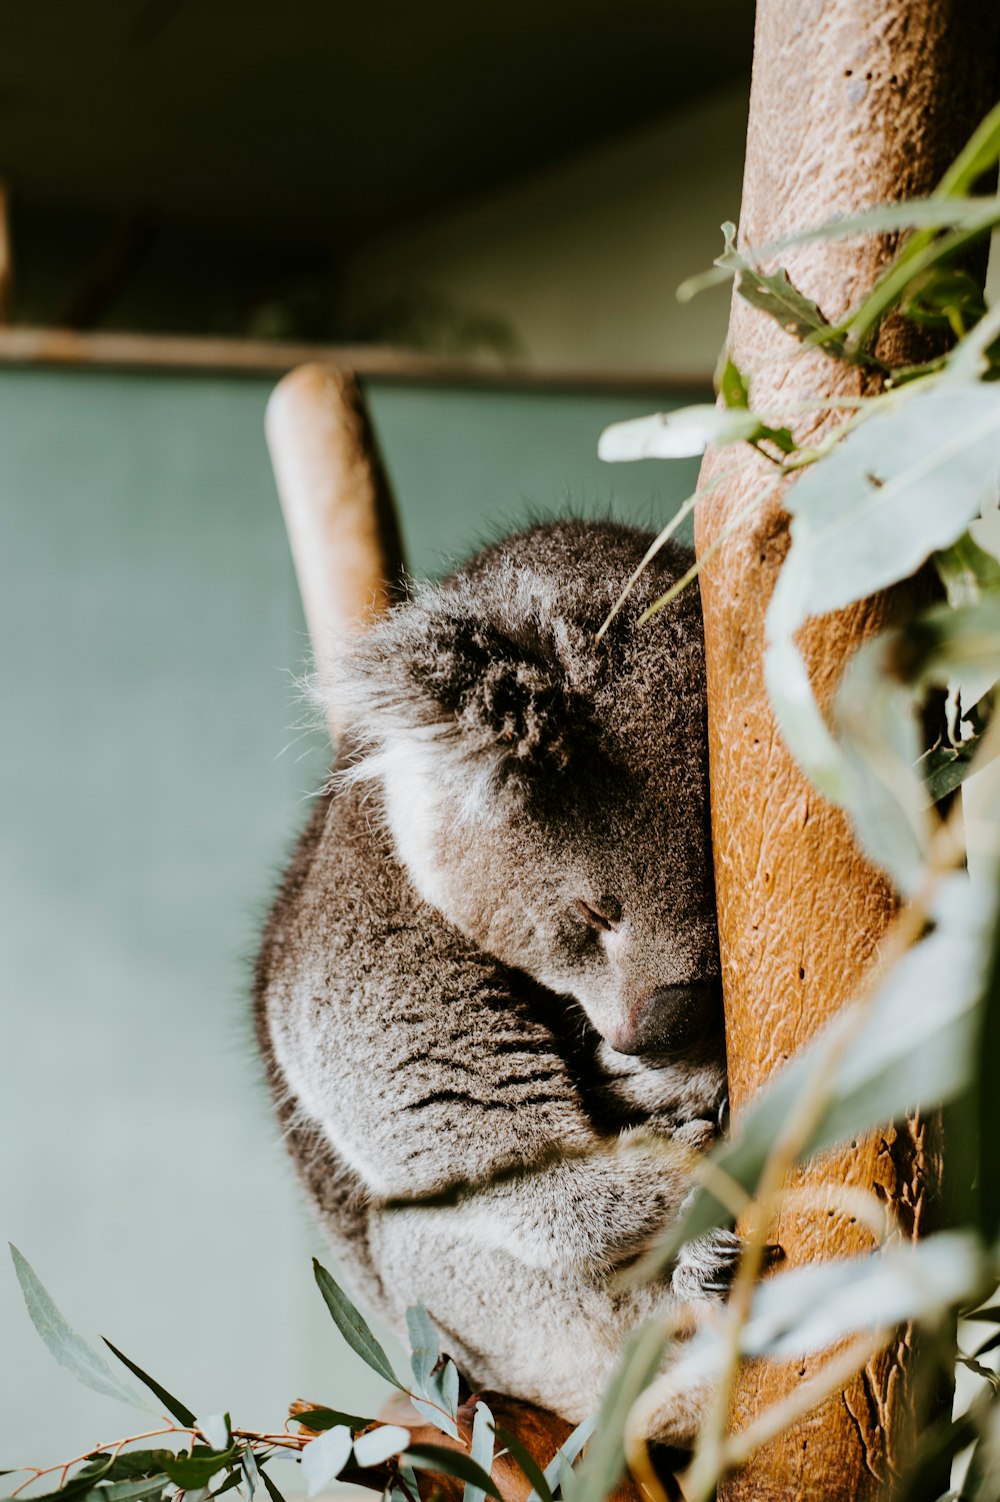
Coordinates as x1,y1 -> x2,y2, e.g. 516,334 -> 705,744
593,96 -> 1000,1502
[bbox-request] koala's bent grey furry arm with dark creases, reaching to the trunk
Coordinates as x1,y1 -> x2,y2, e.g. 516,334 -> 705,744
270,928 -> 708,1266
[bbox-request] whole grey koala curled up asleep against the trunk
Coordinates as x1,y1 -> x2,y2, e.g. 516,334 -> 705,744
257,521 -> 736,1440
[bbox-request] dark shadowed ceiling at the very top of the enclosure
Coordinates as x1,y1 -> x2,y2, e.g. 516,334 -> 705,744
0,0 -> 752,249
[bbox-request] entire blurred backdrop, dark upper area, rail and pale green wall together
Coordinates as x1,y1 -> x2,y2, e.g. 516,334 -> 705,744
0,0 -> 752,1485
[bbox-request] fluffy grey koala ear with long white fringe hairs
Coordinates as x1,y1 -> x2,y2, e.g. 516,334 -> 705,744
333,592 -> 578,778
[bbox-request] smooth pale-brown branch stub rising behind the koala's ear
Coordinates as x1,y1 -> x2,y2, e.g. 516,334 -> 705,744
266,365 -> 402,743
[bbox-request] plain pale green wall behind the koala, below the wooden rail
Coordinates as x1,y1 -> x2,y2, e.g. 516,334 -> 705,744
0,369 -> 695,1484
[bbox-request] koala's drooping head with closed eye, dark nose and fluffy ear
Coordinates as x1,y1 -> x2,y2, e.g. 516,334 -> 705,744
332,521 -> 722,1056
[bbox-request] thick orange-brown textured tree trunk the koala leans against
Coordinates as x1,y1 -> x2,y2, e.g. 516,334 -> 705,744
698,0 -> 1000,1502
